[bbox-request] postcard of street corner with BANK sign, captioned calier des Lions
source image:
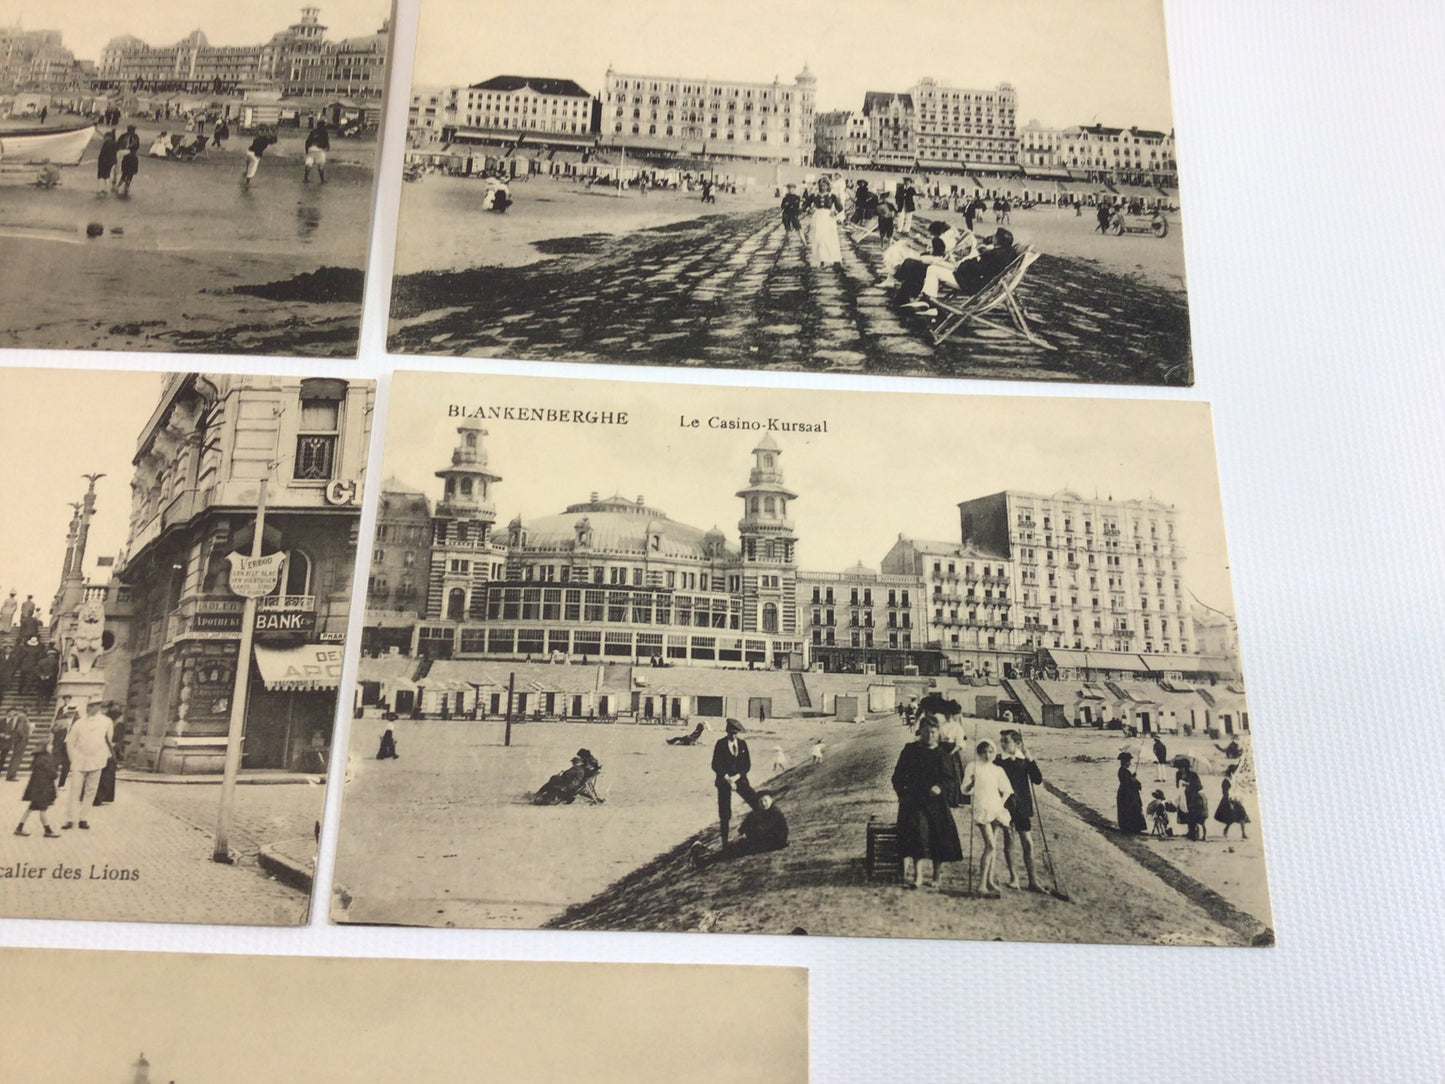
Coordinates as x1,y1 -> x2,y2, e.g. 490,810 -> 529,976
0,369 -> 376,925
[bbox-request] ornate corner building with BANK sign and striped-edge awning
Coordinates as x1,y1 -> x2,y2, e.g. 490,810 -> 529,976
116,373 -> 376,775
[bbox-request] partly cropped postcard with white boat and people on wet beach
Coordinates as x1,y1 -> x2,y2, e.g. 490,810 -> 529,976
0,0 -> 390,357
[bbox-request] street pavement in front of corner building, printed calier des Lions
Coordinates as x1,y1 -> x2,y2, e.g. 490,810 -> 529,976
0,778 -> 324,925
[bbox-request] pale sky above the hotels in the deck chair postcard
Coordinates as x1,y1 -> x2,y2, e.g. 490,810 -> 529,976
413,0 -> 1173,130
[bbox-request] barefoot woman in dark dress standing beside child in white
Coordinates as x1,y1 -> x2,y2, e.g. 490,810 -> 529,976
893,715 -> 964,889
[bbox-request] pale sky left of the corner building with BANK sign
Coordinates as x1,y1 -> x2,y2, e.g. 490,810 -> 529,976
0,369 -> 160,617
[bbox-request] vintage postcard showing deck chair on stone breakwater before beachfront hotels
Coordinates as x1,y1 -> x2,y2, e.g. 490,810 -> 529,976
390,0 -> 1194,384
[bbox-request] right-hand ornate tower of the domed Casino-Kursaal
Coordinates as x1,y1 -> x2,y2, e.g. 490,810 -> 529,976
737,434 -> 798,635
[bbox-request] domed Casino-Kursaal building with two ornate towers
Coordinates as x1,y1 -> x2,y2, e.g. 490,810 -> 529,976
398,419 -> 805,669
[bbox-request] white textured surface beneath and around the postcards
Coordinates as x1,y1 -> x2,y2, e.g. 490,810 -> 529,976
0,0 -> 1445,1081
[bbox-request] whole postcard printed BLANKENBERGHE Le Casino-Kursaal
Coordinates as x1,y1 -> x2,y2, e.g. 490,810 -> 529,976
331,373 -> 1273,945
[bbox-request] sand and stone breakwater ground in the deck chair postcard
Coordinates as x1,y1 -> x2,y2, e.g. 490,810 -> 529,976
389,175 -> 1192,384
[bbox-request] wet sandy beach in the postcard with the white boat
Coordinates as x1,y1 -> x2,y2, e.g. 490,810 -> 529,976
0,124 -> 376,357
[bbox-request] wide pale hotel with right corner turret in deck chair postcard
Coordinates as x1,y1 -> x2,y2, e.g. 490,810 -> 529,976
601,65 -> 818,165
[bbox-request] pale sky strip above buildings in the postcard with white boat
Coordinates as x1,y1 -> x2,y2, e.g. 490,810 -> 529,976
0,0 -> 392,61
